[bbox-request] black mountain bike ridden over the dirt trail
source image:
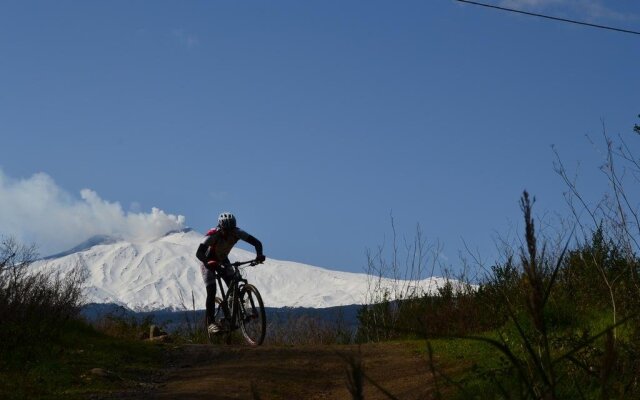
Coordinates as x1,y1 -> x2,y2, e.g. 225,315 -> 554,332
205,260 -> 267,346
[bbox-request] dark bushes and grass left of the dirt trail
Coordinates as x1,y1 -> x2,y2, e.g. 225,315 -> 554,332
0,238 -> 165,399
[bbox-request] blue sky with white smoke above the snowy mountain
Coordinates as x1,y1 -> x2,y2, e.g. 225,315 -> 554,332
0,0 -> 640,272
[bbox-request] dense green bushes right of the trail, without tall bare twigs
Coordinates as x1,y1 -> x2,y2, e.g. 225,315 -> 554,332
358,192 -> 640,399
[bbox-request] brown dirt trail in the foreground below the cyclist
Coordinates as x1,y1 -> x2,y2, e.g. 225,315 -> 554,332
151,343 -> 444,400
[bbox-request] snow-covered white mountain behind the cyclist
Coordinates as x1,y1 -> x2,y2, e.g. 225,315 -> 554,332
33,230 -> 444,311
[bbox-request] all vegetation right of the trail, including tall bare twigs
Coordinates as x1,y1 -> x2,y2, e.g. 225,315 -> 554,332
358,121 -> 640,399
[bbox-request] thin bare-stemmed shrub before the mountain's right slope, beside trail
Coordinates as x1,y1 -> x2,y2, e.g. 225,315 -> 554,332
357,217 -> 488,342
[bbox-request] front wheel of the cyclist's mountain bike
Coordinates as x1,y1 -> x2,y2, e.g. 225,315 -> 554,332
239,285 -> 267,346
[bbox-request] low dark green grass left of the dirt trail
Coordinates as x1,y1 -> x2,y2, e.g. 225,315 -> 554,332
0,321 -> 163,399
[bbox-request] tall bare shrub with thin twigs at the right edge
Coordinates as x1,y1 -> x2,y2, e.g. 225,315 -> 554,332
554,123 -> 640,339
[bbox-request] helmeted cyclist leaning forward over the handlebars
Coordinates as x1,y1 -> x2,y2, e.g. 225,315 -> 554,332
196,212 -> 266,333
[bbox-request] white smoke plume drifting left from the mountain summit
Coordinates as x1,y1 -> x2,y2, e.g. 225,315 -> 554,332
0,169 -> 185,255
